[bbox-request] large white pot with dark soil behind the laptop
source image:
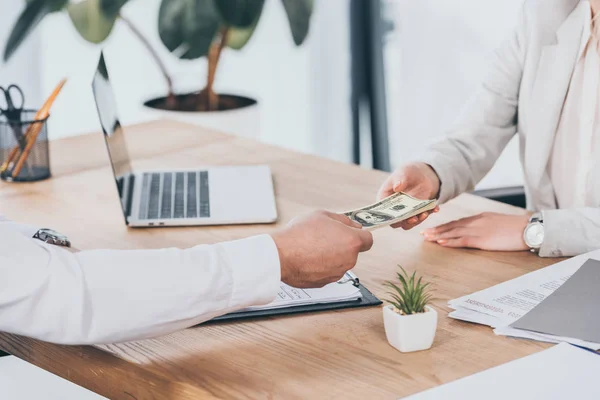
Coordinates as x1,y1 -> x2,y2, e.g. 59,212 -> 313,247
144,93 -> 260,139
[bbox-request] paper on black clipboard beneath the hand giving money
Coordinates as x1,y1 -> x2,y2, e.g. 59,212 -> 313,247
243,282 -> 362,311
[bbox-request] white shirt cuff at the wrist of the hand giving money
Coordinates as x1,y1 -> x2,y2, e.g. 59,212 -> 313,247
220,235 -> 281,308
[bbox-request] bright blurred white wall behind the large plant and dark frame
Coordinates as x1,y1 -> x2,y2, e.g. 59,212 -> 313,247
0,0 -> 523,191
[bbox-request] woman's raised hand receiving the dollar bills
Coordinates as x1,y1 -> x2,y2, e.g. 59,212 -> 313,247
377,163 -> 440,229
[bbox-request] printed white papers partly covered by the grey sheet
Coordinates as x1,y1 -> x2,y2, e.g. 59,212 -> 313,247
448,250 -> 600,350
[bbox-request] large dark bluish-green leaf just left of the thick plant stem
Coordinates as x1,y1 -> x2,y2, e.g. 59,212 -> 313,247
158,0 -> 221,60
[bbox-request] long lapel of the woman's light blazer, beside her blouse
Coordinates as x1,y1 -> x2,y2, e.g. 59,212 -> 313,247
525,2 -> 589,209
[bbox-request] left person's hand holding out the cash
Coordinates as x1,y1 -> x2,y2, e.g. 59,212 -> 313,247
272,211 -> 373,288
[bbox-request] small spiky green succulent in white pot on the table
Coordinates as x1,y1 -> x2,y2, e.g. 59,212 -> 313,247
383,266 -> 437,353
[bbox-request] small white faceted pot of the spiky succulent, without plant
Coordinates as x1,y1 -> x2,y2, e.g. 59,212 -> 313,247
383,305 -> 437,353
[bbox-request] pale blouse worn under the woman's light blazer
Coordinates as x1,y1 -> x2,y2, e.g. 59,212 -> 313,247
549,2 -> 600,208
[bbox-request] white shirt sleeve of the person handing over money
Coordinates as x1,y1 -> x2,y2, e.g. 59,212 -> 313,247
0,217 -> 281,344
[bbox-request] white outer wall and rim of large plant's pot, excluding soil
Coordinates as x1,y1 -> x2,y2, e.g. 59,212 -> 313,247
144,96 -> 260,140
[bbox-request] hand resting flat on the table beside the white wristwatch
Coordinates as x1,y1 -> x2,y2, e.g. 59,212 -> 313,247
423,213 -> 529,251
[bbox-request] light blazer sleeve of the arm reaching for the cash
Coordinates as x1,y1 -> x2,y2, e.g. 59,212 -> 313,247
417,3 -> 527,203
